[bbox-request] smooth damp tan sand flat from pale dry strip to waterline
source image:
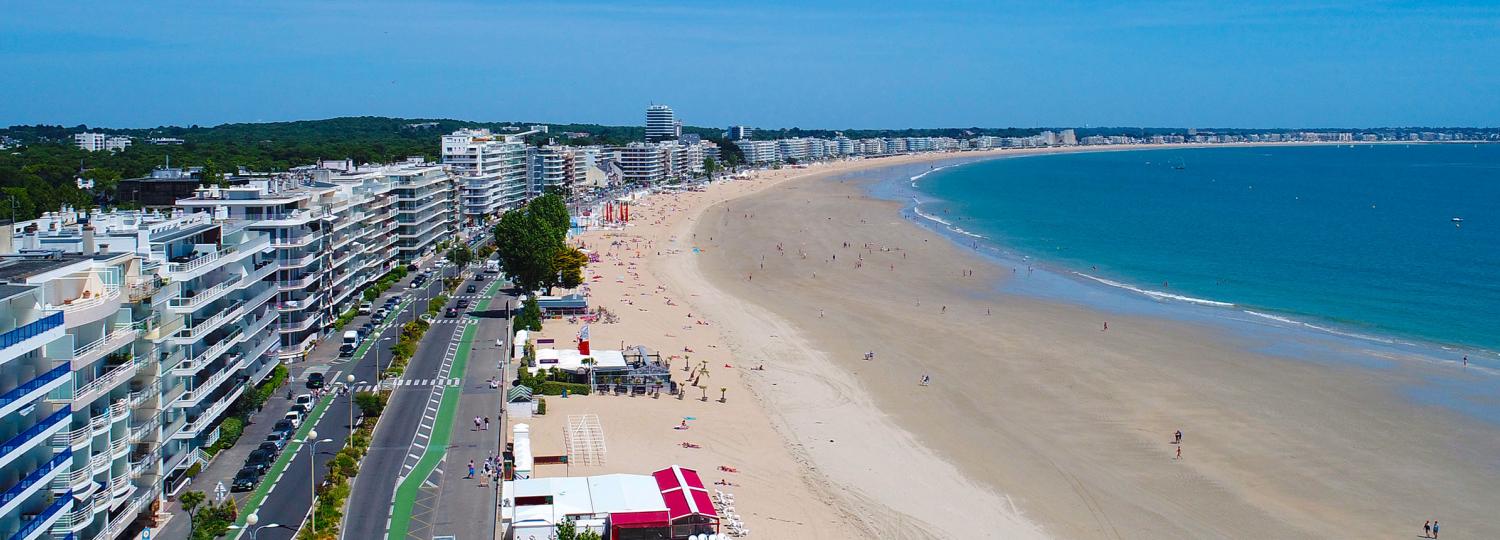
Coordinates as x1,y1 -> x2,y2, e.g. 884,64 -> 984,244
695,145 -> 1497,537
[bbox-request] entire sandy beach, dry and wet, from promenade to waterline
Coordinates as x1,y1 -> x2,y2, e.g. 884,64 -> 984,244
531,145 -> 1500,539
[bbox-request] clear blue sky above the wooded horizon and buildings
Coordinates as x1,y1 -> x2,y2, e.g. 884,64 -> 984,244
0,0 -> 1500,129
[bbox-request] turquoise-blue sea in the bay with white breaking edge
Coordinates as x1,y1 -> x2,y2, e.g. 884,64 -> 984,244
903,144 -> 1500,359
